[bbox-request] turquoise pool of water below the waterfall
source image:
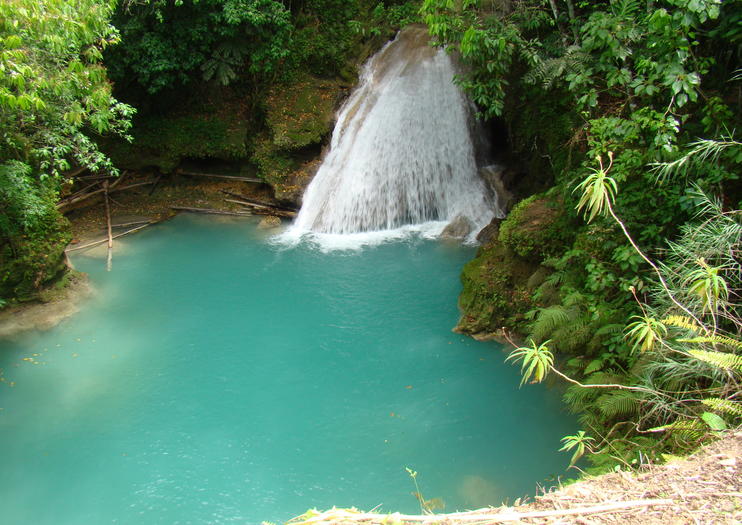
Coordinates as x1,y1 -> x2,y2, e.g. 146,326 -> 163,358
0,216 -> 575,525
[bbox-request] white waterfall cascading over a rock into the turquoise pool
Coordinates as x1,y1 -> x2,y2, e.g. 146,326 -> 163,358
287,27 -> 497,246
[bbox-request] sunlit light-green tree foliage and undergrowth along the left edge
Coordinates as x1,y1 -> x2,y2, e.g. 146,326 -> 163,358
0,0 -> 134,299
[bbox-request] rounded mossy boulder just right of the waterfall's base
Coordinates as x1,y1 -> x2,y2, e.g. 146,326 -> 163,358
498,194 -> 576,262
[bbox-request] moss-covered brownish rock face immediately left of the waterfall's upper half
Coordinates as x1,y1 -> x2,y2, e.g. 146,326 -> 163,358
265,75 -> 341,150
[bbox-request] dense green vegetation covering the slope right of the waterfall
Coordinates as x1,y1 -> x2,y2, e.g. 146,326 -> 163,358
422,0 -> 742,472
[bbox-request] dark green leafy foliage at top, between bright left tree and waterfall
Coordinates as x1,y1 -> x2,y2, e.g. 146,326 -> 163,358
106,0 -> 293,94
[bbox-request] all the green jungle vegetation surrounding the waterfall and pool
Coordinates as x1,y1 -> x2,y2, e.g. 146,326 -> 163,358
0,0 -> 742,470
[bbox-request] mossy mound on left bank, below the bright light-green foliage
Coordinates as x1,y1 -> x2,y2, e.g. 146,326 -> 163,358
0,210 -> 72,302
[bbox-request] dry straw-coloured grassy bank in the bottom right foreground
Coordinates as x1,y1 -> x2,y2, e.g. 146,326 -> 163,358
289,429 -> 742,525
